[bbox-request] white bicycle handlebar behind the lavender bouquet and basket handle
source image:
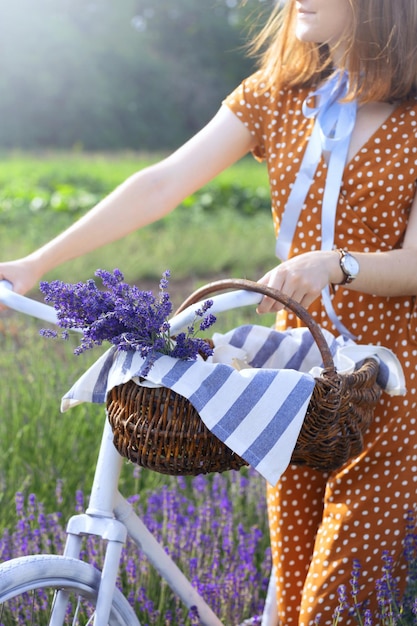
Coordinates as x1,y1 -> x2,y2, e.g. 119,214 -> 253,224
0,280 -> 263,334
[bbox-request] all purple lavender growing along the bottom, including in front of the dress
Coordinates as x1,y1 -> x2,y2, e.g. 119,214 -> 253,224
0,468 -> 417,626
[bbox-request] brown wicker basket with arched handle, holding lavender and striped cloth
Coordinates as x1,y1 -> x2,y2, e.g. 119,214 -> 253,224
107,279 -> 381,475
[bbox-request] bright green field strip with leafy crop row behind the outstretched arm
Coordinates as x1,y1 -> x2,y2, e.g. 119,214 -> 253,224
0,153 -> 270,218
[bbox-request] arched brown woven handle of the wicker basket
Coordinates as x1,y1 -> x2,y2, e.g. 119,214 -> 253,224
175,278 -> 335,371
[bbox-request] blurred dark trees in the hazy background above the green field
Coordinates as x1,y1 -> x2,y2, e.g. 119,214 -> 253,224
0,0 -> 272,150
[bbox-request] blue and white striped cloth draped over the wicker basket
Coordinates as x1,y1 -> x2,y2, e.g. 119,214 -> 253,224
62,325 -> 404,484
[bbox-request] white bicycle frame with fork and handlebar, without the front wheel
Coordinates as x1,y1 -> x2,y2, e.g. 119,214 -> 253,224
0,281 -> 276,626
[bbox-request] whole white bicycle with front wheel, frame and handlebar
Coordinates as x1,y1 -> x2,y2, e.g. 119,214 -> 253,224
0,281 -> 276,626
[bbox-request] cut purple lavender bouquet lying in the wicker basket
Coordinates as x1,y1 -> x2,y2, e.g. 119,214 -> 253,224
40,269 -> 216,371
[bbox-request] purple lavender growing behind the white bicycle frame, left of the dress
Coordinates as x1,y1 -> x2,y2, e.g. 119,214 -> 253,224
0,468 -> 271,626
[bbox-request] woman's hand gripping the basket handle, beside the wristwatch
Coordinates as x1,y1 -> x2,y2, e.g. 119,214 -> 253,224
257,250 -> 343,313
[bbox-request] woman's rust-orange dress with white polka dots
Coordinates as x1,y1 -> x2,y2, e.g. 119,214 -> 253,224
225,73 -> 417,626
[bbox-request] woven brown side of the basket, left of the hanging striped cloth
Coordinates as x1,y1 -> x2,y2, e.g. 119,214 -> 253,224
107,381 -> 247,476
